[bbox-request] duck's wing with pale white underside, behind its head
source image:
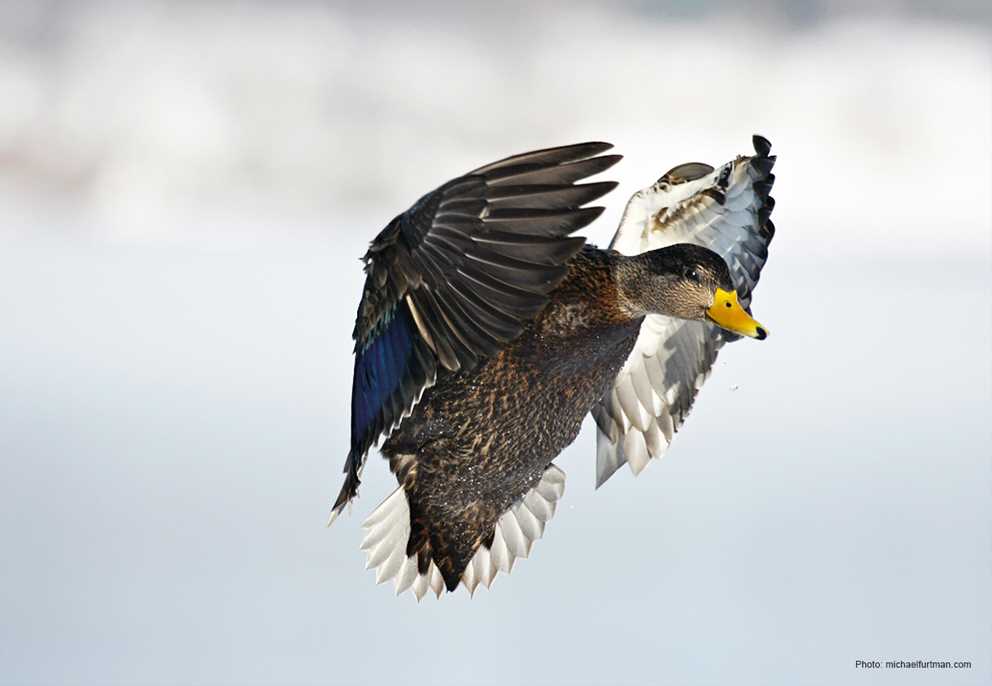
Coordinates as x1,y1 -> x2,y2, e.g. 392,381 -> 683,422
592,136 -> 775,486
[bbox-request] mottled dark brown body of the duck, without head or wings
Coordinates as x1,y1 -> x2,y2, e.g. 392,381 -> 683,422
382,247 -> 641,589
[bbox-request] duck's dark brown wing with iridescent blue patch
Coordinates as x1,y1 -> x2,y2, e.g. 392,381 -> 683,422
334,143 -> 620,512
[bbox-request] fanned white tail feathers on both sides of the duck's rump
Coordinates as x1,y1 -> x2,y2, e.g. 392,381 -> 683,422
362,464 -> 565,600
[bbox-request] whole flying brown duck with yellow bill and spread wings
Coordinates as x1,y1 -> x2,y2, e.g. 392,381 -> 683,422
328,135 -> 776,601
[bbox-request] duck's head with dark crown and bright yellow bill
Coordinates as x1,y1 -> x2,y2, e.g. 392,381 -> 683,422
619,243 -> 768,340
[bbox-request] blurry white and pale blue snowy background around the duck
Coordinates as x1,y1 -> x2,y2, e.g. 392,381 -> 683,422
0,0 -> 992,684
